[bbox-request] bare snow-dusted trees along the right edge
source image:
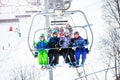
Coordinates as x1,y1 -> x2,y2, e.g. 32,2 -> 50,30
100,0 -> 120,80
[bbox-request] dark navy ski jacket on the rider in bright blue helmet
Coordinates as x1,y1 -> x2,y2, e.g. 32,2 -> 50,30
48,37 -> 60,48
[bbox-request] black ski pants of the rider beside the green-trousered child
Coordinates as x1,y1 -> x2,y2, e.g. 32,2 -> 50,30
48,50 -> 59,65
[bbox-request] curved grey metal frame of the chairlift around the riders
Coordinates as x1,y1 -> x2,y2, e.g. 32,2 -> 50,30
28,10 -> 93,55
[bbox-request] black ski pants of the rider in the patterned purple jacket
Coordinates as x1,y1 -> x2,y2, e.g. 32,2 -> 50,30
61,48 -> 75,63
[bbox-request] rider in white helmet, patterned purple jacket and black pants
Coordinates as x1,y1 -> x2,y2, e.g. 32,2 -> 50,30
60,30 -> 75,67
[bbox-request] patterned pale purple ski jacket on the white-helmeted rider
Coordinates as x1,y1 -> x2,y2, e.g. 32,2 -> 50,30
59,36 -> 71,48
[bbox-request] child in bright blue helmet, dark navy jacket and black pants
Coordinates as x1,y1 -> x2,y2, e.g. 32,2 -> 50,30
48,30 -> 59,67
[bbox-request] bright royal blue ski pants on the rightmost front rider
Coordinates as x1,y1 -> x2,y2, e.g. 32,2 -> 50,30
75,47 -> 86,64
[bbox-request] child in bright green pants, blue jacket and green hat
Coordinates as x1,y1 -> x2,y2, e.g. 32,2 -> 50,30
36,34 -> 48,68
